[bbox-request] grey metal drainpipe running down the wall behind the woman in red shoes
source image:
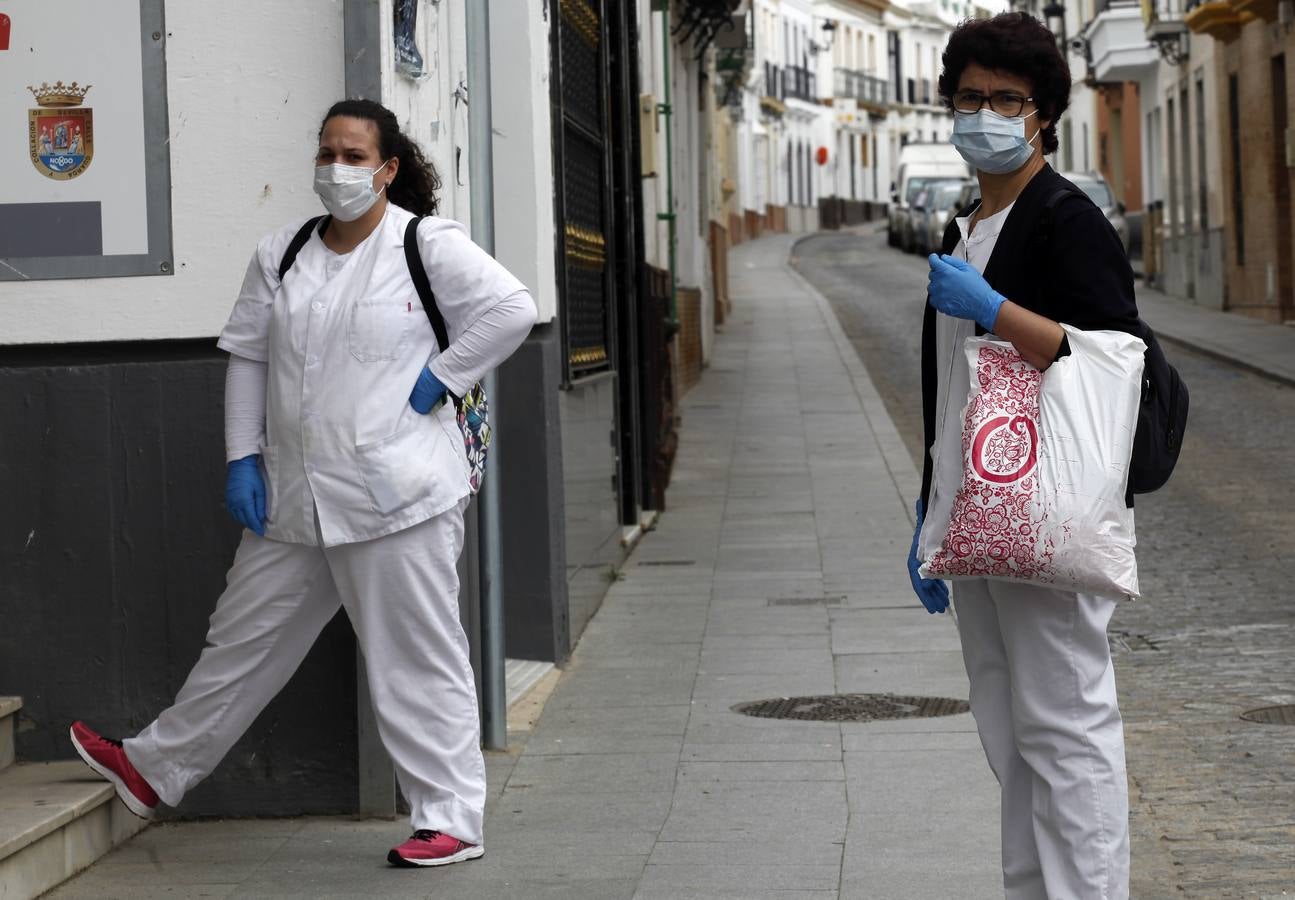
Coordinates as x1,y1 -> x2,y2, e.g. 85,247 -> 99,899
465,0 -> 508,750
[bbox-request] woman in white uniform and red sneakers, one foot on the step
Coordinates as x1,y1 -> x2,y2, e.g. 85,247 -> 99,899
71,100 -> 535,865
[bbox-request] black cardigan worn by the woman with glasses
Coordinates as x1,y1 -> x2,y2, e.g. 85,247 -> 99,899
922,164 -> 1142,506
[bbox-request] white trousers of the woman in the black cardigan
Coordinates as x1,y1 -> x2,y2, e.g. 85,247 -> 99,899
954,579 -> 1129,900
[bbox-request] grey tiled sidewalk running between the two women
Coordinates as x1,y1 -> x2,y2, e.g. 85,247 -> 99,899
52,237 -> 1002,900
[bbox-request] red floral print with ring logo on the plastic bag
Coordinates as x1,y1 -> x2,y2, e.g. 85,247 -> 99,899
927,347 -> 1064,584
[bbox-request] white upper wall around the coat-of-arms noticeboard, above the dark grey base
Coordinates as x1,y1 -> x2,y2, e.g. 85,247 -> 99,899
0,0 -> 481,344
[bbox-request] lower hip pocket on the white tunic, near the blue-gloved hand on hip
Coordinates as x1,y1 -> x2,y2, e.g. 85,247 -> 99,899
355,416 -> 444,515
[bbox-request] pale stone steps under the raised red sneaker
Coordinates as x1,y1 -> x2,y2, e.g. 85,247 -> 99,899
0,760 -> 148,900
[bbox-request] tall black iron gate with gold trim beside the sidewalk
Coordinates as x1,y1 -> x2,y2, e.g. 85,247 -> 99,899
549,0 -> 675,524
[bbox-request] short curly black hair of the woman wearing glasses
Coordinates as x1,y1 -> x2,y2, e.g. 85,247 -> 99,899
939,13 -> 1070,153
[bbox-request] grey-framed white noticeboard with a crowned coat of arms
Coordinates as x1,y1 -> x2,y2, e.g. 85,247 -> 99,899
0,0 -> 172,281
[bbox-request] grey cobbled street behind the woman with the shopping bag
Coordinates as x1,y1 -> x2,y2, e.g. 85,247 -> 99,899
795,231 -> 1295,900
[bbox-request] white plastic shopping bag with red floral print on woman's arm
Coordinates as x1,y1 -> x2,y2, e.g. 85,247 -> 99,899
921,325 -> 1146,597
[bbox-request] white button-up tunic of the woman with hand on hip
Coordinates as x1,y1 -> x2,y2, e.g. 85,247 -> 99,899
218,203 -> 535,546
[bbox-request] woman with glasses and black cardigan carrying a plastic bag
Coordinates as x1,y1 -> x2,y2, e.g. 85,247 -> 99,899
908,13 -> 1138,900
